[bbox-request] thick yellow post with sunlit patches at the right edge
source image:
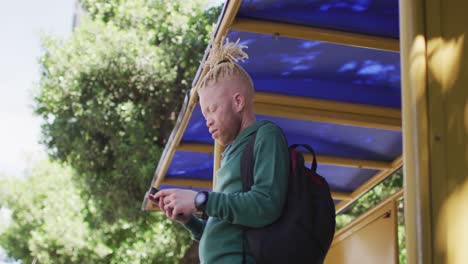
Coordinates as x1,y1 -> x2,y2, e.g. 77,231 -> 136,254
400,0 -> 468,264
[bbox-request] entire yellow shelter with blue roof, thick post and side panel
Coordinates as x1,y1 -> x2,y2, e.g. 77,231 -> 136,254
143,0 -> 468,263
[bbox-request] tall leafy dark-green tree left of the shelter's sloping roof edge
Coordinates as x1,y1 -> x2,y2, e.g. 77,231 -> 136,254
35,0 -> 219,222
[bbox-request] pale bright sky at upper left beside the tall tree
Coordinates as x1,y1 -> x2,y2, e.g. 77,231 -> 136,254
0,0 -> 75,177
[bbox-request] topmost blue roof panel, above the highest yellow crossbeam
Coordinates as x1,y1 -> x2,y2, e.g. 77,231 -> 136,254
237,0 -> 399,39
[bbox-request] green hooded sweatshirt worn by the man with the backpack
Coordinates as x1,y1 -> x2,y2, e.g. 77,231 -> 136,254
185,121 -> 289,264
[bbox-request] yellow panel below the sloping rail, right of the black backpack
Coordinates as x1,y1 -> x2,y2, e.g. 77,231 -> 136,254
325,200 -> 398,264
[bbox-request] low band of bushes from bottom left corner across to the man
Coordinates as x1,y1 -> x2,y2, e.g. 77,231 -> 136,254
0,162 -> 190,263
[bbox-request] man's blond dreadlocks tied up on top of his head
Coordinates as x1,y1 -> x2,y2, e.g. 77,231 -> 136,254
199,38 -> 254,95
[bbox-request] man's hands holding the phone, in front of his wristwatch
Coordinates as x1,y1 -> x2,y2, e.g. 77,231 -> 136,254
148,189 -> 197,223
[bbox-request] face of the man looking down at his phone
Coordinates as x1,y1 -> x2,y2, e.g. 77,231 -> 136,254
198,81 -> 241,146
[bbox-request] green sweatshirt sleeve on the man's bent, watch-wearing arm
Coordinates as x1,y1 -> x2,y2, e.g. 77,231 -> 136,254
206,126 -> 289,227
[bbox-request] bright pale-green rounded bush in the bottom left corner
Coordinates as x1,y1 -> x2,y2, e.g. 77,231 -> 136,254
0,164 -> 111,263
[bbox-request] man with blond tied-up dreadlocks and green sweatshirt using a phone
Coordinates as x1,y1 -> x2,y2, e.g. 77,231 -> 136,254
149,41 -> 289,264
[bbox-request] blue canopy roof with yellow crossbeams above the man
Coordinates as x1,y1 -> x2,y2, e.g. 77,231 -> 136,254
143,0 -> 402,210
